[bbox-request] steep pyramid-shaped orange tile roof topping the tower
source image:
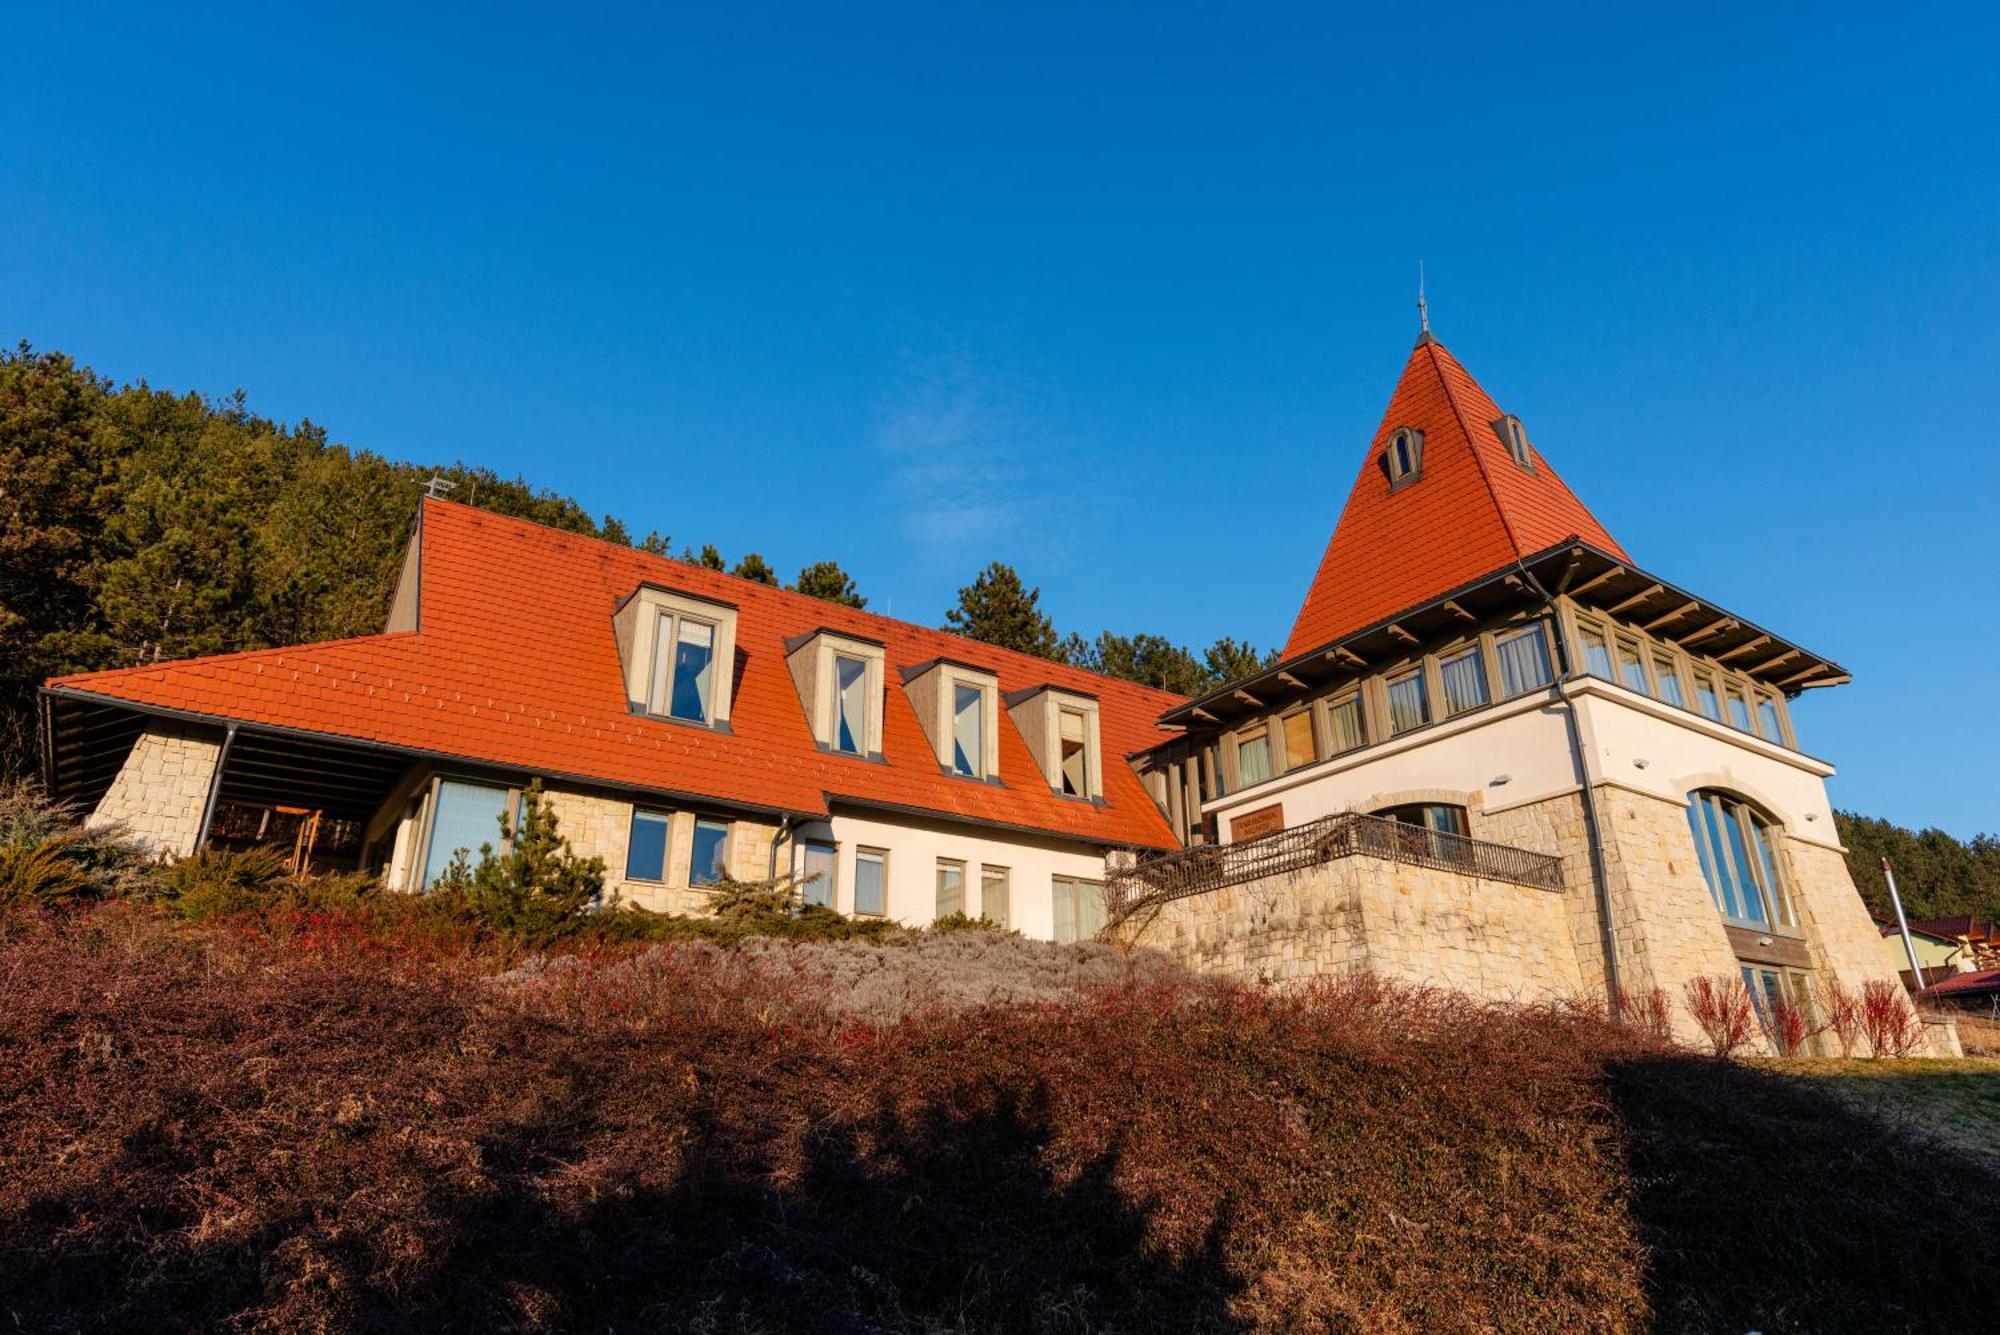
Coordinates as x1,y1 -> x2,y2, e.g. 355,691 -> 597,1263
1284,336 -> 1630,658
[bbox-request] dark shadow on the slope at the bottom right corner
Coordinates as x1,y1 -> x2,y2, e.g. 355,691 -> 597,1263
1608,1057 -> 2000,1331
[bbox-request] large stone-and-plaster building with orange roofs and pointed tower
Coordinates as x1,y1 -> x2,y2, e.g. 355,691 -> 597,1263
44,328 -> 1952,1055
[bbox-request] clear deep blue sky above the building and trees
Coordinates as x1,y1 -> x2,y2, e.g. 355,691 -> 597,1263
0,4 -> 2000,833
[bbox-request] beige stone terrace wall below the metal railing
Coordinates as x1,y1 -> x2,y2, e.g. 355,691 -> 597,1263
1128,857 -> 1582,1001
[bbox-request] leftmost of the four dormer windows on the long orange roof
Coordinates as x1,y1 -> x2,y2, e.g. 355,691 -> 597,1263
612,584 -> 736,727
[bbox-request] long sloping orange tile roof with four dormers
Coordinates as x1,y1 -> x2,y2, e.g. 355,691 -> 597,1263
50,500 -> 1182,847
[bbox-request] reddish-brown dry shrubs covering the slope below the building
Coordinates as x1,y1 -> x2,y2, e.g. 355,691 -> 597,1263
0,907 -> 2000,1331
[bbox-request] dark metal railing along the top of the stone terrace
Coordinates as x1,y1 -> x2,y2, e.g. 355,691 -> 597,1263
1104,811 -> 1562,915
